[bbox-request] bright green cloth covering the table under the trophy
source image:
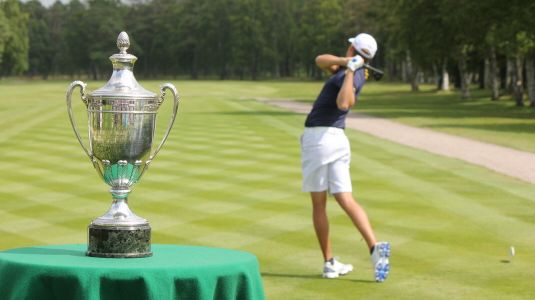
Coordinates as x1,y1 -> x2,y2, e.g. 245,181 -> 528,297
0,245 -> 264,300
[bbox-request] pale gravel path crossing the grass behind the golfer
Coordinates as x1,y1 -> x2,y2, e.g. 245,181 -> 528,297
264,99 -> 535,184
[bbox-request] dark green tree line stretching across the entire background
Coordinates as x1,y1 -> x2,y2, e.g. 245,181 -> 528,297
0,0 -> 535,106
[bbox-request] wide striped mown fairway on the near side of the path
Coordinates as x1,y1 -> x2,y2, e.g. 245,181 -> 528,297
0,81 -> 535,299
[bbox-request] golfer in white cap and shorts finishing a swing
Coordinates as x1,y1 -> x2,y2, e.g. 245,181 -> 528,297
301,33 -> 390,282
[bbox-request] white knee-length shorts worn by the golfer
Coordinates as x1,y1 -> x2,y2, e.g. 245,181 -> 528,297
301,127 -> 353,194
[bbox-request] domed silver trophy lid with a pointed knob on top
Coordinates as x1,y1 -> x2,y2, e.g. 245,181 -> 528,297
90,31 -> 156,99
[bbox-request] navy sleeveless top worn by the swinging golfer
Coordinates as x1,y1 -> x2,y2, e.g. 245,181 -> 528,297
305,68 -> 366,129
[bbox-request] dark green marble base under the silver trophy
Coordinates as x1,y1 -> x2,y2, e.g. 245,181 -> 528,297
86,224 -> 152,258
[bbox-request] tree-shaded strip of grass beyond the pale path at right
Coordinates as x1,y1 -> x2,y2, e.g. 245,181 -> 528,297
357,84 -> 535,152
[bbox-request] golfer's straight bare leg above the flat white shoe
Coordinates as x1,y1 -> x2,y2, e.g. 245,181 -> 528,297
310,191 -> 332,261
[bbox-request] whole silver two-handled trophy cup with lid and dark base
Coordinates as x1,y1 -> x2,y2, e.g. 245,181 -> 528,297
67,32 -> 179,257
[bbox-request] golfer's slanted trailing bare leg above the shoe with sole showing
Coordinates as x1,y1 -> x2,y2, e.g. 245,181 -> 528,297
333,192 -> 377,249
